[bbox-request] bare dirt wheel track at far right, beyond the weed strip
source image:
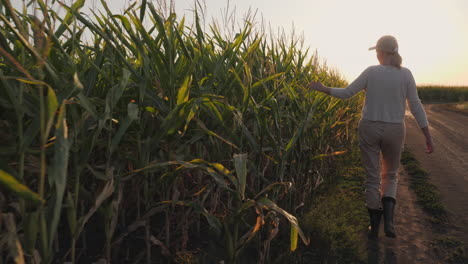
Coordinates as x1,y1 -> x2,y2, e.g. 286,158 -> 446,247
406,105 -> 468,245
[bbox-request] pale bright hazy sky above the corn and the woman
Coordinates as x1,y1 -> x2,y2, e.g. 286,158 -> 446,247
13,0 -> 468,86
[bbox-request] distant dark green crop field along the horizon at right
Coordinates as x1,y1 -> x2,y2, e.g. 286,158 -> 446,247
418,85 -> 468,103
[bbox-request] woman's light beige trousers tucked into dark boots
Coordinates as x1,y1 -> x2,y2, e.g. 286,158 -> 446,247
358,119 -> 406,209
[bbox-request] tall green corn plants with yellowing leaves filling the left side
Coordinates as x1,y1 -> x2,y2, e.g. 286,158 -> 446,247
0,0 -> 361,263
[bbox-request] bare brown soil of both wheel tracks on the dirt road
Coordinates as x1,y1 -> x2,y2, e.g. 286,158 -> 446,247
368,105 -> 468,264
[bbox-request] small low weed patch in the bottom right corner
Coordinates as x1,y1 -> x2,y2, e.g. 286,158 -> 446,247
431,236 -> 468,263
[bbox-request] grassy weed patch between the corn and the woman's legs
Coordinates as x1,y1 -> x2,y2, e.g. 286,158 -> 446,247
301,167 -> 368,263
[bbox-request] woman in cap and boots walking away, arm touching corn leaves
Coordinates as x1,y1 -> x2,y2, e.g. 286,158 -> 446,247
309,36 -> 434,239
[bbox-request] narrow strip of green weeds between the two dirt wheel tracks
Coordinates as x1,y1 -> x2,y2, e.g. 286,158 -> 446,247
401,150 -> 447,220
